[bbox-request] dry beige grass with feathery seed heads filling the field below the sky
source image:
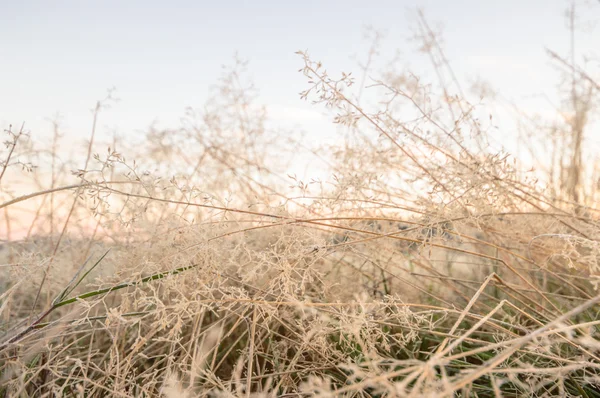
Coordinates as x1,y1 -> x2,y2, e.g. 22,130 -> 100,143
0,8 -> 600,397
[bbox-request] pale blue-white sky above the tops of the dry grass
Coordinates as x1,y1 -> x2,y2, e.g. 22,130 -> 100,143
0,0 -> 600,163
